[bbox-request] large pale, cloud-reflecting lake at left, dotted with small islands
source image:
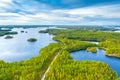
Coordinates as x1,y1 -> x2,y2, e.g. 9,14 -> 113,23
0,27 -> 54,62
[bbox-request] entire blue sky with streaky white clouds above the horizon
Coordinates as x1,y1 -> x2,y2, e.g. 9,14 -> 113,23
0,0 -> 120,25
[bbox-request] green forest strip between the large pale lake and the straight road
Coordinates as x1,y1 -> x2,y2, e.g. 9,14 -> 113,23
0,43 -> 60,80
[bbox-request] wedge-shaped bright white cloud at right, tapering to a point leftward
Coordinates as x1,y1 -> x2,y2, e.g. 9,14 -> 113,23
62,5 -> 120,18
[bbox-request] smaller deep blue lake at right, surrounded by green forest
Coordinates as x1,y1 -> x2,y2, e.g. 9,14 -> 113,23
70,49 -> 120,77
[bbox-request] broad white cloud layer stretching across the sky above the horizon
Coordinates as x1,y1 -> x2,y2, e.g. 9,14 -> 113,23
0,0 -> 120,25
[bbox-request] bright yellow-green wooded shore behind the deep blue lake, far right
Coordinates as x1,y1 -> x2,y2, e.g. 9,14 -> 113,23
99,39 -> 120,58
